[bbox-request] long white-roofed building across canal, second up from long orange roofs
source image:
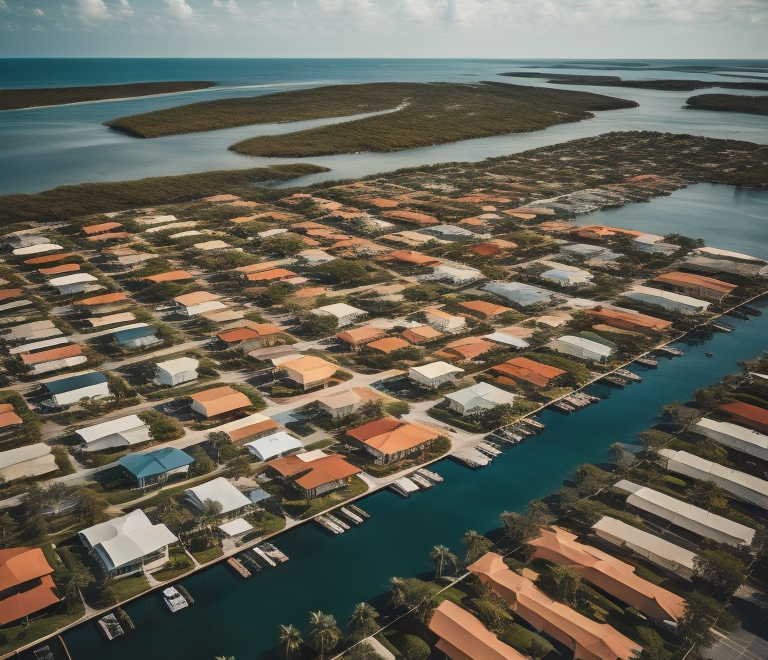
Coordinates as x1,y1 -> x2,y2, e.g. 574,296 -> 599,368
614,479 -> 755,546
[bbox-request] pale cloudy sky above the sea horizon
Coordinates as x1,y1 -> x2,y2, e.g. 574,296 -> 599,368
0,0 -> 768,59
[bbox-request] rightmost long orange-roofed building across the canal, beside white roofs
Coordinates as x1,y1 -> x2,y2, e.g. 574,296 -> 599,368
528,526 -> 685,622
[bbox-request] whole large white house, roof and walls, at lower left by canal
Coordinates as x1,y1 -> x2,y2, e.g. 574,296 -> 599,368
80,509 -> 178,577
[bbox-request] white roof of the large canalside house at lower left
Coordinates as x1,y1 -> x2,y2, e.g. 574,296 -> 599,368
80,509 -> 178,569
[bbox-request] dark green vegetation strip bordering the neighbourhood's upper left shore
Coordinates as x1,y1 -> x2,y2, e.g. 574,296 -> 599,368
0,163 -> 327,224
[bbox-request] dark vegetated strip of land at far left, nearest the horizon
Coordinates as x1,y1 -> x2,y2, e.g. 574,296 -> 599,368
0,80 -> 216,110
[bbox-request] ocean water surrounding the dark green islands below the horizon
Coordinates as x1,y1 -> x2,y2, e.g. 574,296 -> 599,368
0,59 -> 768,194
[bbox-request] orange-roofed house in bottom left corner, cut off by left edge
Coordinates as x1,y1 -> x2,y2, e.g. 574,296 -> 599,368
0,548 -> 60,626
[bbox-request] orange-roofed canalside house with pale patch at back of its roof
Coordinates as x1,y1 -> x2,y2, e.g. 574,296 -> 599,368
267,449 -> 362,500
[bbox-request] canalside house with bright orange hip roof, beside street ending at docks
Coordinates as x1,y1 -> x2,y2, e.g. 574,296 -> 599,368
347,417 -> 440,465
